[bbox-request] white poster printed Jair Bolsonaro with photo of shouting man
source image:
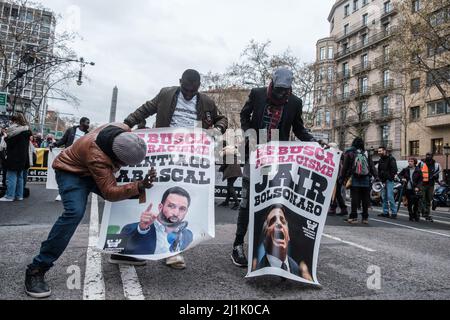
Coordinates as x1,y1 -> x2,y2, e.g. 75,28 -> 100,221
247,141 -> 341,285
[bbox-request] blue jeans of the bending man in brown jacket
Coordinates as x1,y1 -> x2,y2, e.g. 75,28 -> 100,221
29,171 -> 98,271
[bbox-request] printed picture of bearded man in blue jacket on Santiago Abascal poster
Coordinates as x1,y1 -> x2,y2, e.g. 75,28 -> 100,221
121,187 -> 193,255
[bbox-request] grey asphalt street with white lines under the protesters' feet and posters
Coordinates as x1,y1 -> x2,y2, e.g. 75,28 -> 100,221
0,185 -> 450,300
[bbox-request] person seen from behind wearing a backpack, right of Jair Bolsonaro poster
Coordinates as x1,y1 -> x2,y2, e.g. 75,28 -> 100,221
338,137 -> 377,224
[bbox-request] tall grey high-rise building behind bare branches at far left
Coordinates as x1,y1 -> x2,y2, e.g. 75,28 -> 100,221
0,1 -> 56,119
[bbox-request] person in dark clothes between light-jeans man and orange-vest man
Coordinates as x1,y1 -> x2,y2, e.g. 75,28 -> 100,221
399,158 -> 423,222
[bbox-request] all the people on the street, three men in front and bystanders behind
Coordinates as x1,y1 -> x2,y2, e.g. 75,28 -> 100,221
0,68 -> 440,298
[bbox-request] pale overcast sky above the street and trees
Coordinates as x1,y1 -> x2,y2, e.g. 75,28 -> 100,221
42,0 -> 334,123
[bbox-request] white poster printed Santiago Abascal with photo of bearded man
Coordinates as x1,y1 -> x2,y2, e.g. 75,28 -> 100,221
98,128 -> 215,260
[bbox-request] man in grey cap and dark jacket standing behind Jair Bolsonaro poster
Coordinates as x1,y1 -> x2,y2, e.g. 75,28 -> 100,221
231,68 -> 324,267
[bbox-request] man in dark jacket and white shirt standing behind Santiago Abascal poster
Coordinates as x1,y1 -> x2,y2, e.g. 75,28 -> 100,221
122,69 -> 228,269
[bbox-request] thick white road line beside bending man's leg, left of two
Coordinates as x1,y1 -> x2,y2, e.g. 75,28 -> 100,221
83,194 -> 106,300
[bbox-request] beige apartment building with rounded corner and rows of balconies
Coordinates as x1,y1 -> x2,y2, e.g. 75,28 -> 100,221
313,0 -> 402,156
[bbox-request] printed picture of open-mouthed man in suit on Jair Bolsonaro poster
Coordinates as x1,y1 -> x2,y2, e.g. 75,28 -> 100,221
253,204 -> 312,281
